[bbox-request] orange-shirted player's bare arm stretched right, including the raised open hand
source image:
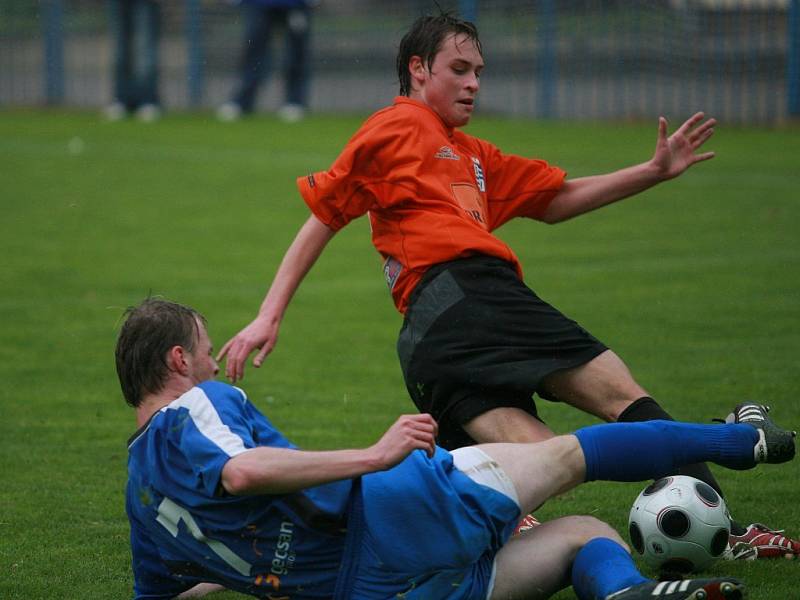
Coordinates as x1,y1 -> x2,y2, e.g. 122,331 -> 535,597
541,113 -> 716,223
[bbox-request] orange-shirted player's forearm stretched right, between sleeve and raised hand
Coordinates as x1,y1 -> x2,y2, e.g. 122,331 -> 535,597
542,162 -> 665,223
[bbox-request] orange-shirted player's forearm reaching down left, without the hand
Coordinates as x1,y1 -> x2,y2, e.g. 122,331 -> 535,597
259,215 -> 335,321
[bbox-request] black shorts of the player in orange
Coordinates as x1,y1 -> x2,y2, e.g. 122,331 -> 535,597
397,255 -> 607,449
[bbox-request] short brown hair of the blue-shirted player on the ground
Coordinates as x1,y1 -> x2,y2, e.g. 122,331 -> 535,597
115,298 -> 206,406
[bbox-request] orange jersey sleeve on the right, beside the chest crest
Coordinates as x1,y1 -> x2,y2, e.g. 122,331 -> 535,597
481,142 -> 566,230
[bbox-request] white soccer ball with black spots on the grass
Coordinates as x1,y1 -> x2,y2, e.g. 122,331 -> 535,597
628,475 -> 731,573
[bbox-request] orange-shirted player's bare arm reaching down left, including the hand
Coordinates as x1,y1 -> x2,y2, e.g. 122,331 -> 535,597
217,214 -> 335,381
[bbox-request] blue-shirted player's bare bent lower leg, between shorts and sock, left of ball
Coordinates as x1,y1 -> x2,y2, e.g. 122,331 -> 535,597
490,516 -> 622,600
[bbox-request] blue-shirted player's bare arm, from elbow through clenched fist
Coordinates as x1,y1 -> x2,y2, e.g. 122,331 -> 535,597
221,414 -> 437,495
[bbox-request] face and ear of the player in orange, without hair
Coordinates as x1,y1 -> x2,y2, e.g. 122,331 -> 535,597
410,34 -> 483,127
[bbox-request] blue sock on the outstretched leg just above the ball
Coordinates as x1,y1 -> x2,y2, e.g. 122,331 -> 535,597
575,421 -> 758,481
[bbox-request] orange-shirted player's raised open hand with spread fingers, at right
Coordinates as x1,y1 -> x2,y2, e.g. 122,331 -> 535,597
651,112 -> 717,179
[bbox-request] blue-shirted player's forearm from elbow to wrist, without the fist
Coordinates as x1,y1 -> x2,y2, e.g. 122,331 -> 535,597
217,447 -> 384,496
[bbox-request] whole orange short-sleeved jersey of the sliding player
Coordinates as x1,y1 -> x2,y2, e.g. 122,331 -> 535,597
297,97 -> 565,313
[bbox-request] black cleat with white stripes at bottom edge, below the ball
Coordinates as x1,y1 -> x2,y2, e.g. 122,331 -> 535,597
605,577 -> 744,600
